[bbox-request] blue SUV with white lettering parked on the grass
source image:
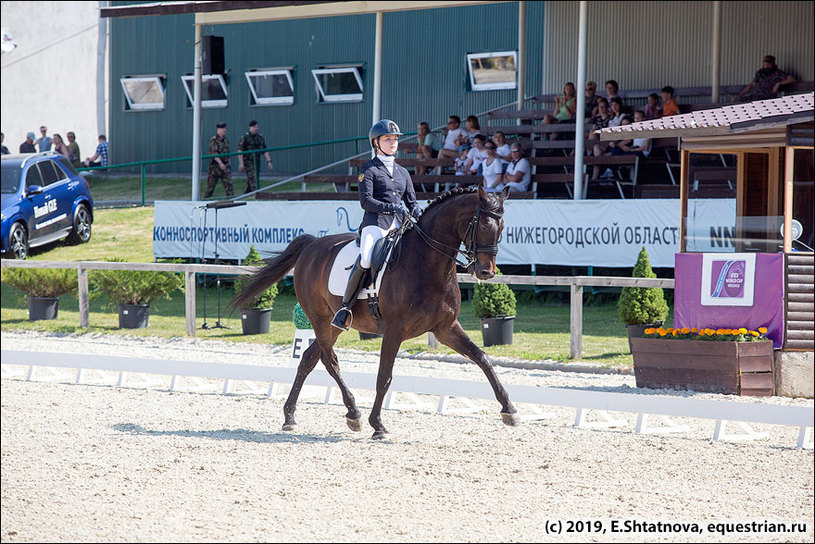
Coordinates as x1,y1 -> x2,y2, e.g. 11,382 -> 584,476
0,152 -> 93,259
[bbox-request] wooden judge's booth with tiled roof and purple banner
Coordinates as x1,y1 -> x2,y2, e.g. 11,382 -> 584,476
600,92 -> 815,397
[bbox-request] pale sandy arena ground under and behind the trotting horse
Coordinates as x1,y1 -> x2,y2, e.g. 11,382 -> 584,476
0,332 -> 815,542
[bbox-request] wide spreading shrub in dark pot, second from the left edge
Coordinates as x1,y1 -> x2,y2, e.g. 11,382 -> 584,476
91,259 -> 184,329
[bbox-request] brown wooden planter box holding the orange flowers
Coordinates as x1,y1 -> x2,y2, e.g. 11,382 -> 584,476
631,338 -> 775,397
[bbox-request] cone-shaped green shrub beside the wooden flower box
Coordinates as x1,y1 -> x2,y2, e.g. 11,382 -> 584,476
617,246 -> 668,349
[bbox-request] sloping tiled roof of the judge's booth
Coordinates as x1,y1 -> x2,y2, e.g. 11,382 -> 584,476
595,92 -> 815,140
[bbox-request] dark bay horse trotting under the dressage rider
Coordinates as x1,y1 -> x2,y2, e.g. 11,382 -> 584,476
231,187 -> 520,439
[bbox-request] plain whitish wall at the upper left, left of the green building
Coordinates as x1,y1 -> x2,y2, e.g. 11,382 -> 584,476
0,1 -> 107,162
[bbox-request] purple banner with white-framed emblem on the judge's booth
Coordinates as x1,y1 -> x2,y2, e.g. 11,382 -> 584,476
674,253 -> 784,348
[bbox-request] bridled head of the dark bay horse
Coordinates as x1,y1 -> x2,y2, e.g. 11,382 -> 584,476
462,186 -> 509,280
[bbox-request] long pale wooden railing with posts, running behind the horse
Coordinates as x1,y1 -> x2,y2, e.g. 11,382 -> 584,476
0,259 -> 674,359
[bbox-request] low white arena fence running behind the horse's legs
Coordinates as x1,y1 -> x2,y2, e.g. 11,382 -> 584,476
0,350 -> 815,449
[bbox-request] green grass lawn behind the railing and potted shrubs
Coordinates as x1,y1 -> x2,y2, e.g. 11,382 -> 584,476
0,202 -> 672,367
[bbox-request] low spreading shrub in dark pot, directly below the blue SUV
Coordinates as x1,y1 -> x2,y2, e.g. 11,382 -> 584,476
3,268 -> 77,321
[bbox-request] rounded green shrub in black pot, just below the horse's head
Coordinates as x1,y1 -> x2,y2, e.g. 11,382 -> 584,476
473,269 -> 516,346
